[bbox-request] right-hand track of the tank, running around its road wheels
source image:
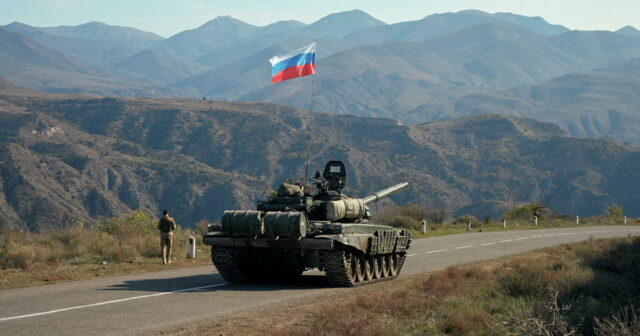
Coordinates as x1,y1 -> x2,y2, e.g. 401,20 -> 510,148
321,248 -> 406,287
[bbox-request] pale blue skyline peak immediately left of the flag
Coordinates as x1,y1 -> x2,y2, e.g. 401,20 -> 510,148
151,16 -> 259,60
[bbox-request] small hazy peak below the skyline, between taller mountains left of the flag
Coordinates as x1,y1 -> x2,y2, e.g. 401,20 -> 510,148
115,49 -> 205,84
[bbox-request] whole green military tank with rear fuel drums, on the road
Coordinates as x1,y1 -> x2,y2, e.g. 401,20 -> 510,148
203,161 -> 411,287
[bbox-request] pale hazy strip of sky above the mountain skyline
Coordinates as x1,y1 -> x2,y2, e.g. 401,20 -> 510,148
0,0 -> 640,37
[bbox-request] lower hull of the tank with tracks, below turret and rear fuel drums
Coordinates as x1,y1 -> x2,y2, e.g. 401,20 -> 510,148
203,223 -> 411,287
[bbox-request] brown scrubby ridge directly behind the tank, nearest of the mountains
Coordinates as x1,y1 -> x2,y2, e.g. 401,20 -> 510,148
0,92 -> 640,230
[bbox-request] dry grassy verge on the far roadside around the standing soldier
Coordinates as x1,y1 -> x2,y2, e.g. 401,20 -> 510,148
0,211 -> 210,289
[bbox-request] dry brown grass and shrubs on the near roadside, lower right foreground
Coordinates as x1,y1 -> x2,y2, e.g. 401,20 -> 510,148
168,238 -> 640,336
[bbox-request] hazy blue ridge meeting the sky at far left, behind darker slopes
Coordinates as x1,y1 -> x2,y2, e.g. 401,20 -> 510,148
4,22 -> 163,67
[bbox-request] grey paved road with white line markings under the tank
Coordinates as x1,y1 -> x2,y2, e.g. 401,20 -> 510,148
0,226 -> 640,335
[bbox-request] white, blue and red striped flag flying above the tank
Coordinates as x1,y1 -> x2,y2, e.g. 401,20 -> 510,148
269,42 -> 316,84
